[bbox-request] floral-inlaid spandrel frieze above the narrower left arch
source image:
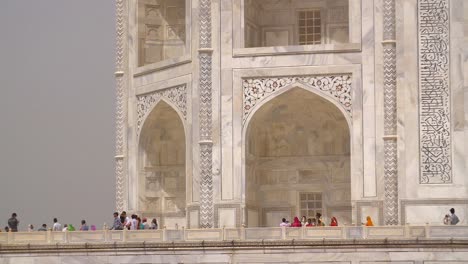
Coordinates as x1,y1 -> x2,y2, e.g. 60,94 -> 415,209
137,84 -> 187,132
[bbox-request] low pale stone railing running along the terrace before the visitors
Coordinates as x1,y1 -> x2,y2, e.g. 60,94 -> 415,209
0,225 -> 468,244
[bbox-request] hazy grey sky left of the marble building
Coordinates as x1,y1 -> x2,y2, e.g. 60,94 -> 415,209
0,0 -> 115,230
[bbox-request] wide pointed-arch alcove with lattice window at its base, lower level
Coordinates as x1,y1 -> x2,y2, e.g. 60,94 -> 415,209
245,88 -> 351,227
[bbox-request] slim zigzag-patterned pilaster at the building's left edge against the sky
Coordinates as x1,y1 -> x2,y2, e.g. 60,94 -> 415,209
115,0 -> 127,211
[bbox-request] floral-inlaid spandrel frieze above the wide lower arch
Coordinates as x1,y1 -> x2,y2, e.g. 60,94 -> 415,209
242,74 -> 352,124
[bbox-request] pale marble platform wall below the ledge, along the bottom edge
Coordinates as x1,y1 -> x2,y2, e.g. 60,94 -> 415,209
0,248 -> 468,264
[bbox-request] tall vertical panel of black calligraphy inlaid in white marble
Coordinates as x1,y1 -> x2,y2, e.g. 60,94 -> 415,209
419,0 -> 452,184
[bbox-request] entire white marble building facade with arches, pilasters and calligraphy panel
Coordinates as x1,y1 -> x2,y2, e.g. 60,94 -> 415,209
116,0 -> 468,228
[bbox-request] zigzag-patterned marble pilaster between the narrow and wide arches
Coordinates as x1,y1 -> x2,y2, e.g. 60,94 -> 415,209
198,0 -> 214,228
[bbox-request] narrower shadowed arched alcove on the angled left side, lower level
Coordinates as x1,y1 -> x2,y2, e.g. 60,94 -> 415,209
138,101 -> 186,225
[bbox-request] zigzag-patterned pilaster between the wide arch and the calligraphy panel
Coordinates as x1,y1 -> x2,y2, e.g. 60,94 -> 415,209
382,0 -> 398,225
